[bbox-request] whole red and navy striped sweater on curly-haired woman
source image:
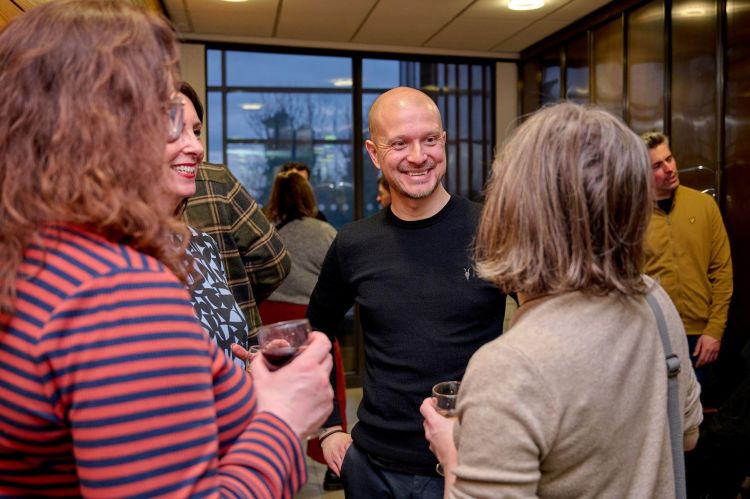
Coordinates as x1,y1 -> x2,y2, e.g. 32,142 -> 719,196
0,226 -> 307,497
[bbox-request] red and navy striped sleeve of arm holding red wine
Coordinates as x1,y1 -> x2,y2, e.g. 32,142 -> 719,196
49,273 -> 305,498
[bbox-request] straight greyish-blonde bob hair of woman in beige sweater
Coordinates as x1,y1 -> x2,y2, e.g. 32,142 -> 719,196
475,103 -> 652,296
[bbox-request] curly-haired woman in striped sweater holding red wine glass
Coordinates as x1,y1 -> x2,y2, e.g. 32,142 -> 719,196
0,0 -> 332,497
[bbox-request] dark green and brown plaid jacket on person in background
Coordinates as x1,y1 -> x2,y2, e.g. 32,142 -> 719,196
183,163 -> 292,337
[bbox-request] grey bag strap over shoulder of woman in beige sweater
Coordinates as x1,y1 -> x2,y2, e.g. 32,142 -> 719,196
646,293 -> 687,499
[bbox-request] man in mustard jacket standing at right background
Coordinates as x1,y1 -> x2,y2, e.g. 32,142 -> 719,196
642,132 -> 732,381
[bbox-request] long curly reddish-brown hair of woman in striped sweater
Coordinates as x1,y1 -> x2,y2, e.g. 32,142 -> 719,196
0,0 -> 190,311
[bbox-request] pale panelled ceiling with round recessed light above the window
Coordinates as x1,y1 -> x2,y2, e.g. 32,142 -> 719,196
166,0 -> 609,58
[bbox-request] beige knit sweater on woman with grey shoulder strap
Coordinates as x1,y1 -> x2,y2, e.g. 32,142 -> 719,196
450,279 -> 702,499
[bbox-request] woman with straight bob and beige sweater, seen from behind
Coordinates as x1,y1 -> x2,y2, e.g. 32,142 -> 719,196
421,103 -> 702,498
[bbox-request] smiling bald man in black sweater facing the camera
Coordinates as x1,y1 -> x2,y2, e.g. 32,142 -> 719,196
308,87 -> 505,499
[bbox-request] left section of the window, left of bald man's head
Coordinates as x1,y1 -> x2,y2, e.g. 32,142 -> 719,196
206,50 -> 354,227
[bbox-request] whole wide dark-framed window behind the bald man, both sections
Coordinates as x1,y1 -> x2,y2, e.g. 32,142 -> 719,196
206,48 -> 494,228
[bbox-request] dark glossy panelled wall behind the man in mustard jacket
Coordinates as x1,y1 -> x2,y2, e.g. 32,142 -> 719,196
519,0 -> 750,403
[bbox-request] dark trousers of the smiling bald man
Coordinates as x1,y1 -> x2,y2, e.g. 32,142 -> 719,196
341,444 -> 445,499
